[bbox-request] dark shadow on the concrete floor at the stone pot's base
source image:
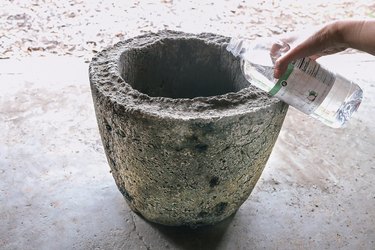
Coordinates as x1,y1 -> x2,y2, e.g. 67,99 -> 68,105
147,214 -> 235,250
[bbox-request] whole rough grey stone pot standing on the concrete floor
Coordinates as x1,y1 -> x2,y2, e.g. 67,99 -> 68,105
89,31 -> 287,226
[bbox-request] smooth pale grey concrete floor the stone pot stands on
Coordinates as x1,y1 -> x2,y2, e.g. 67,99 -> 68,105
0,54 -> 375,249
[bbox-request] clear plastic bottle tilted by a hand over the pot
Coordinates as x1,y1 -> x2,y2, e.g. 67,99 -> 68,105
227,38 -> 363,128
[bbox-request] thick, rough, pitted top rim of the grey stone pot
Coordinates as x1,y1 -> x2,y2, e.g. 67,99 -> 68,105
89,30 -> 282,119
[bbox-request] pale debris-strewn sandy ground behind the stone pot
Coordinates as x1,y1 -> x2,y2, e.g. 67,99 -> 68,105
0,0 -> 375,60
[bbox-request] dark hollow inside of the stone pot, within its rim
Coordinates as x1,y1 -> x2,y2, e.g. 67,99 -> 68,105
120,39 -> 249,98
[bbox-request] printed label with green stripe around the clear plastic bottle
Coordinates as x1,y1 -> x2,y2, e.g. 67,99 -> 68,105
269,58 -> 336,114
